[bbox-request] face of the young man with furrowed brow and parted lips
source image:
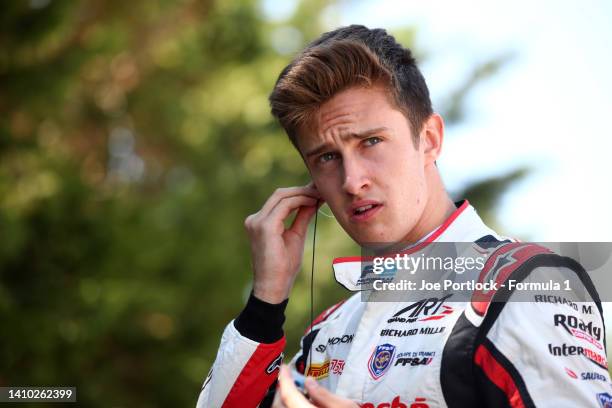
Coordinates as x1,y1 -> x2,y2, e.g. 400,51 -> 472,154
298,87 -> 432,244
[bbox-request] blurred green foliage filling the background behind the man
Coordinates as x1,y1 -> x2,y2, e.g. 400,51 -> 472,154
0,0 -> 522,407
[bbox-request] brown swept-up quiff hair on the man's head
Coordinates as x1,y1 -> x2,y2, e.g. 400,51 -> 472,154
270,25 -> 433,150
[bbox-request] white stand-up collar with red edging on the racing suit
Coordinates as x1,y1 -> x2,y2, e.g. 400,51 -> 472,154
333,200 -> 497,291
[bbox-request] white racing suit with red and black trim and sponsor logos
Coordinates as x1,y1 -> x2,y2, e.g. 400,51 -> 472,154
197,201 -> 612,408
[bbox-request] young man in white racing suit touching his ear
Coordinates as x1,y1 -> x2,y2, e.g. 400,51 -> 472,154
198,26 -> 612,408
